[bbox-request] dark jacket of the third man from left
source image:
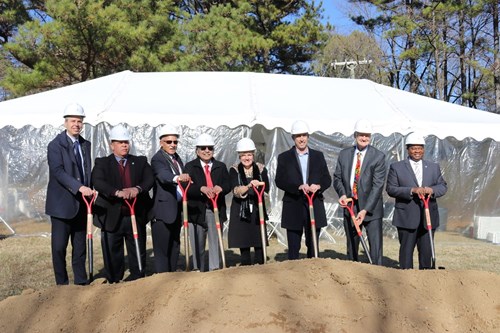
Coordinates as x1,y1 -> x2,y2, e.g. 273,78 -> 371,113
151,149 -> 184,224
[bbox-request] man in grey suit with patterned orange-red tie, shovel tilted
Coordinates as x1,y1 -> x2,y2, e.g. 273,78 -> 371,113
333,119 -> 386,265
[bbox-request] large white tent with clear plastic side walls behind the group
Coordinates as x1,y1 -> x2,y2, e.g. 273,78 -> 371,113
0,71 -> 500,235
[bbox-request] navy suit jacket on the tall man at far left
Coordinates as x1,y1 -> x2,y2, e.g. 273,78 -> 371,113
45,131 -> 92,219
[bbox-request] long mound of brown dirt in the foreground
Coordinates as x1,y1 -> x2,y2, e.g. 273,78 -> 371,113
0,259 -> 500,333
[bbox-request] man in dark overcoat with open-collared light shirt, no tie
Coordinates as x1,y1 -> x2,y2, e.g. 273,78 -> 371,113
275,121 -> 332,260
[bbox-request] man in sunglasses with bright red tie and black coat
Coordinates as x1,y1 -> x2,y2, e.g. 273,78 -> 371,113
185,133 -> 231,272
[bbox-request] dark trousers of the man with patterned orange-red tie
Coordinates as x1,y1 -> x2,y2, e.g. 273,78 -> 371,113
344,217 -> 383,265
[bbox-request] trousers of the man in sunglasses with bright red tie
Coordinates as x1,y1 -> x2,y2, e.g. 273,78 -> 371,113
189,208 -> 222,272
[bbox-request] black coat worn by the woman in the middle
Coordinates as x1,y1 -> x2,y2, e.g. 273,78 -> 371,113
228,164 -> 269,248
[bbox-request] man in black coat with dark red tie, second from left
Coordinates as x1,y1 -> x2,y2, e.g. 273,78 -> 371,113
92,125 -> 154,283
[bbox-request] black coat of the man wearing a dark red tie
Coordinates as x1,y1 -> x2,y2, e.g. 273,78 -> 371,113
92,154 -> 154,232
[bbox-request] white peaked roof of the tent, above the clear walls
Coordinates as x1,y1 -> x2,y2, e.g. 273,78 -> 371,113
0,71 -> 500,141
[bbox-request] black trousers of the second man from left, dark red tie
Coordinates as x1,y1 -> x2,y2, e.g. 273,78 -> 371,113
101,216 -> 146,283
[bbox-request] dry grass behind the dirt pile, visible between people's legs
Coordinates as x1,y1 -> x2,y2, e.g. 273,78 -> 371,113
0,221 -> 500,300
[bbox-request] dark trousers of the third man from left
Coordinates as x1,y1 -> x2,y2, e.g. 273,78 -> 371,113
151,215 -> 181,273
